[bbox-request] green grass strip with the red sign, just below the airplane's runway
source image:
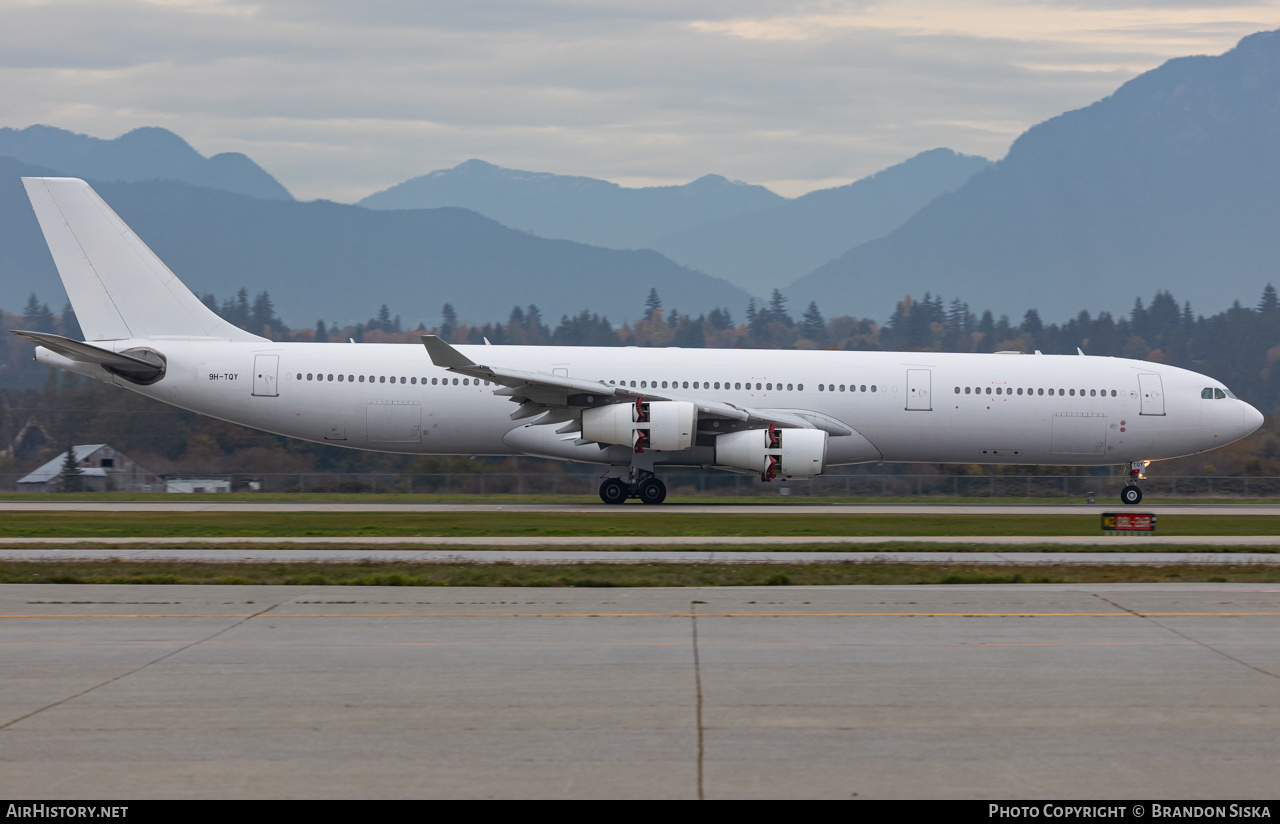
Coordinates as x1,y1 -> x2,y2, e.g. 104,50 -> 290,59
0,508 -> 1280,539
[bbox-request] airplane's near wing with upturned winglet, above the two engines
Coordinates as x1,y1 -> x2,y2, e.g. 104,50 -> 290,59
422,335 -> 852,436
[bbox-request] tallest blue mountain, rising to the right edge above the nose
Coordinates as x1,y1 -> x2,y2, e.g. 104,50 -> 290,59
788,26 -> 1280,321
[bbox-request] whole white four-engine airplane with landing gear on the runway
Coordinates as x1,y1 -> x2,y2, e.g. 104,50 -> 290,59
14,178 -> 1262,504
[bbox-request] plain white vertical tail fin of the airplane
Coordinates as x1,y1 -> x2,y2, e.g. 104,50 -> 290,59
22,178 -> 265,340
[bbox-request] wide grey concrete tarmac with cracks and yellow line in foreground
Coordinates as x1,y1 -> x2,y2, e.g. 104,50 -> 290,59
0,585 -> 1280,802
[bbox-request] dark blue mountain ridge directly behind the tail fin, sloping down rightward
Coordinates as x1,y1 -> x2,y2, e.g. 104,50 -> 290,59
0,157 -> 749,326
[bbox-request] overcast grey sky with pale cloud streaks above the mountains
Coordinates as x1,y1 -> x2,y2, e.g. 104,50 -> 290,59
0,0 -> 1280,201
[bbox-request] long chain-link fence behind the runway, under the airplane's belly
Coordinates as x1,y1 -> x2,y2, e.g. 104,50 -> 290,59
0,470 -> 1280,500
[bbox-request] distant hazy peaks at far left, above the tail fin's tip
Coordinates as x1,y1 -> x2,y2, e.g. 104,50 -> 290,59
0,125 -> 293,201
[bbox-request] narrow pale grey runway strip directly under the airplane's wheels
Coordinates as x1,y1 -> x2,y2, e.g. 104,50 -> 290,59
0,495 -> 1280,516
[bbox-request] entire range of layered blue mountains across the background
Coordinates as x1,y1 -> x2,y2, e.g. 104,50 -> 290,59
0,32 -> 1280,325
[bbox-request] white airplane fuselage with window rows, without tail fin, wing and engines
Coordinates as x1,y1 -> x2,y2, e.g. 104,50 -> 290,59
41,339 -> 1261,466
